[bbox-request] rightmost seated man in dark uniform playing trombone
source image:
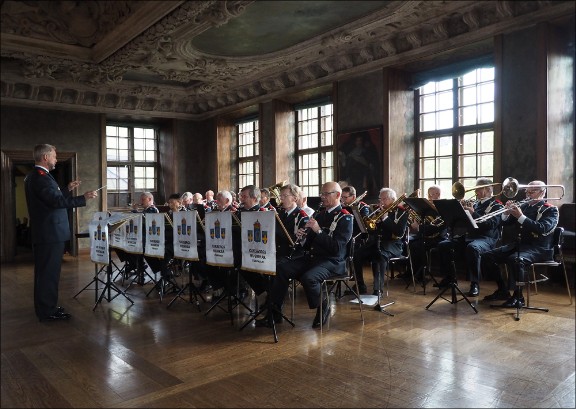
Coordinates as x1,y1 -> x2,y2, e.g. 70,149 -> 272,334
482,180 -> 559,308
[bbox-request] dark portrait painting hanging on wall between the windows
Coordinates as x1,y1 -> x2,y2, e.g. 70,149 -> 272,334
337,128 -> 382,198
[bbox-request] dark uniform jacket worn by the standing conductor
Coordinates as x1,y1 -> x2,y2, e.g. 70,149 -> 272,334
24,167 -> 86,243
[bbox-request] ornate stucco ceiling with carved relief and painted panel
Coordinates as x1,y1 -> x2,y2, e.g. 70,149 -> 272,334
1,0 -> 575,119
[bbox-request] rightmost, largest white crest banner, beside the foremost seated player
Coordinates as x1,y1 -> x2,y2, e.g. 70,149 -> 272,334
241,211 -> 276,274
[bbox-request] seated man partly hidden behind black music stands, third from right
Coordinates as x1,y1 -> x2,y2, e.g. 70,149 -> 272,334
409,185 -> 448,282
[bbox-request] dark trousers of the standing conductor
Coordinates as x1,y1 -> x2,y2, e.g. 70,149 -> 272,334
32,241 -> 66,319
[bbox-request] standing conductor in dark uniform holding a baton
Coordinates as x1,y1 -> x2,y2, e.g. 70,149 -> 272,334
24,144 -> 98,321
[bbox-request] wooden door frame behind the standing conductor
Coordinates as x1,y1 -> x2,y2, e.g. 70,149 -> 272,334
0,150 -> 78,263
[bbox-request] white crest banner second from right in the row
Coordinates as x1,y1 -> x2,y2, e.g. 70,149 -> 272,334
204,212 -> 234,267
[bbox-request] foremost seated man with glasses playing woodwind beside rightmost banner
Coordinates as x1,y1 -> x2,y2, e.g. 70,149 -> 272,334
270,182 -> 353,328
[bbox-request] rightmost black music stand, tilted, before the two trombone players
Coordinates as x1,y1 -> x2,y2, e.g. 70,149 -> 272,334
426,199 -> 478,314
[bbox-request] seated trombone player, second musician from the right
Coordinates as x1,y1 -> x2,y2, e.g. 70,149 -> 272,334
434,178 -> 503,297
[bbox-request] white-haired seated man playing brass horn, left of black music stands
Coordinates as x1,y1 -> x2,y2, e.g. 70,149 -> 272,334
354,188 -> 408,295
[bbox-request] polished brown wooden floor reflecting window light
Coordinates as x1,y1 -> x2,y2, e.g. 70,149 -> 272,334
1,250 -> 575,408
